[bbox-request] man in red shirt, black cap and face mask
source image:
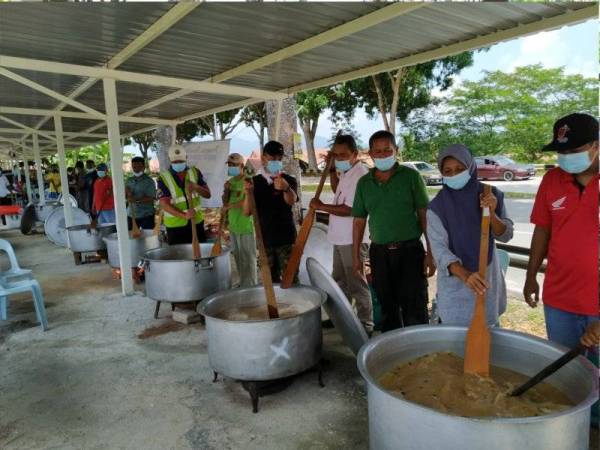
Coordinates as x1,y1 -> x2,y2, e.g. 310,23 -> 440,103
523,114 -> 599,348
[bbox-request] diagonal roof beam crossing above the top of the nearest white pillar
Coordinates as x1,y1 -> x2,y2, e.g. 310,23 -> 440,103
22,0 -> 204,148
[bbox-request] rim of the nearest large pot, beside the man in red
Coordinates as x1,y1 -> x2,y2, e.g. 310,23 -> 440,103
356,324 -> 598,425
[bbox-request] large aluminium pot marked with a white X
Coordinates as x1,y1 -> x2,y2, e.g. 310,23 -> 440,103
200,285 -> 326,381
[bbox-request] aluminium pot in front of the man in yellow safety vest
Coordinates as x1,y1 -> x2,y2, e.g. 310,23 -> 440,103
143,244 -> 231,303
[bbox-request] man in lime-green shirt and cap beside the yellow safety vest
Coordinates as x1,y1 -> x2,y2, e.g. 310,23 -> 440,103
223,153 -> 258,287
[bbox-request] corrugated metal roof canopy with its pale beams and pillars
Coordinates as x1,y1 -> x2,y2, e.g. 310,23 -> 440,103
0,1 -> 597,295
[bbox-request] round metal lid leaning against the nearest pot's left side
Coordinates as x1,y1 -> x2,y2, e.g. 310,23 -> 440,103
306,258 -> 369,355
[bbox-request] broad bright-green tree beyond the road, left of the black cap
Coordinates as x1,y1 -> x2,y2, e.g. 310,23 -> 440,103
407,65 -> 598,162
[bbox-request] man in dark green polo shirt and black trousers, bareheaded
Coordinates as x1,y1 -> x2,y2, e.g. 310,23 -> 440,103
352,130 -> 435,332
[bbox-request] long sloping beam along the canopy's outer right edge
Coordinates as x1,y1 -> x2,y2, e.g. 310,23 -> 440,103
175,6 -> 598,122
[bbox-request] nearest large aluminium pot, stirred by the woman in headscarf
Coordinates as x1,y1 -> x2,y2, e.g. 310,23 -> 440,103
358,325 -> 598,450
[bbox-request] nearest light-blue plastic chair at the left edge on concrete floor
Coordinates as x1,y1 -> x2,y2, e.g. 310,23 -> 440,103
0,239 -> 48,331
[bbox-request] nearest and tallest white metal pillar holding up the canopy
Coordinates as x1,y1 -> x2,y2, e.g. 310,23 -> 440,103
102,78 -> 133,295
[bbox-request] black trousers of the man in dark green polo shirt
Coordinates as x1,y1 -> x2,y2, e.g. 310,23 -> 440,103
369,240 -> 429,332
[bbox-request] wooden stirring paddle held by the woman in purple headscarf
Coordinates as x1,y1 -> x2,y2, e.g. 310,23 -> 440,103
464,184 -> 492,377
